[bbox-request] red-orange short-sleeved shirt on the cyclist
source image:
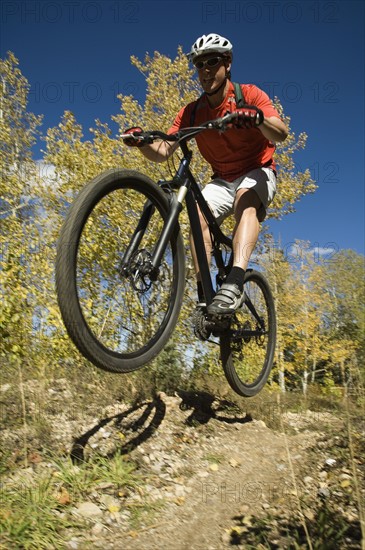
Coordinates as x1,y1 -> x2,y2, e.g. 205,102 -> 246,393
168,82 -> 280,181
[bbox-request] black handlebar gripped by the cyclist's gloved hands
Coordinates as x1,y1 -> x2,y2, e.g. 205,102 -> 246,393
120,112 -> 249,144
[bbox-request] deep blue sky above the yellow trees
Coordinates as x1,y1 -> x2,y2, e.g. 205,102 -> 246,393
0,0 -> 365,256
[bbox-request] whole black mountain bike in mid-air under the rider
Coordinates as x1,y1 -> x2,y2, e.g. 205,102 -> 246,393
56,113 -> 276,397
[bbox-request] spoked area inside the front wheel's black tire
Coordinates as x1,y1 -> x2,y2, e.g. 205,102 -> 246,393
77,189 -> 178,353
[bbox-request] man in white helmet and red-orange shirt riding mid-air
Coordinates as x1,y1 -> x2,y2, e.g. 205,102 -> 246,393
125,33 -> 288,316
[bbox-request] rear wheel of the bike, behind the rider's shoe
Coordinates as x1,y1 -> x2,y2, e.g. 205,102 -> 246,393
220,270 -> 276,397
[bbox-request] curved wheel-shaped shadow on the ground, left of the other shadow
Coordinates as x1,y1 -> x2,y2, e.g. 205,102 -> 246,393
70,396 -> 166,463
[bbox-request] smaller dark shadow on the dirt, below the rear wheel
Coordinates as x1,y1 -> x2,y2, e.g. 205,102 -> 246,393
176,390 -> 253,426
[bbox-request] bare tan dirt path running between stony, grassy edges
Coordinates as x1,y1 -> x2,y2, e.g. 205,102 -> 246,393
104,396 -> 316,550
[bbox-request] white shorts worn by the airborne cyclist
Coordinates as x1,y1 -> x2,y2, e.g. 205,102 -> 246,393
202,167 -> 276,223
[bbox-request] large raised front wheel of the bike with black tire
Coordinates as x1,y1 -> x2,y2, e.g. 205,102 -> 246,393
56,169 -> 185,372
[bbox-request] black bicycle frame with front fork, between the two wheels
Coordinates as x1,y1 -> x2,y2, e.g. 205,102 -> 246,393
121,142 -> 232,305
